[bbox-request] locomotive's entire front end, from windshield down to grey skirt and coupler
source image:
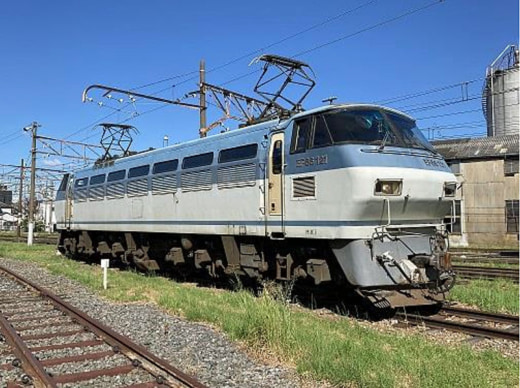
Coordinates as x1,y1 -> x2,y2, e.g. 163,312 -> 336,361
286,105 -> 456,307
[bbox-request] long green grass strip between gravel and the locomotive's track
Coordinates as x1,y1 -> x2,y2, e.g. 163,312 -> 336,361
0,243 -> 519,387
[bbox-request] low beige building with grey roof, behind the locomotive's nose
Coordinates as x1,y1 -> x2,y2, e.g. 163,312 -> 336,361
434,134 -> 519,249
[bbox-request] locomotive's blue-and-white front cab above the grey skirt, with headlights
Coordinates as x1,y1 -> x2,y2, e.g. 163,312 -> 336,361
285,105 -> 457,226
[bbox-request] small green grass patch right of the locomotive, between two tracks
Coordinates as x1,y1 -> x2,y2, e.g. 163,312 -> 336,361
450,279 -> 519,314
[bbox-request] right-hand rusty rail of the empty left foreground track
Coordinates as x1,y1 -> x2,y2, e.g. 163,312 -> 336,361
0,265 -> 207,388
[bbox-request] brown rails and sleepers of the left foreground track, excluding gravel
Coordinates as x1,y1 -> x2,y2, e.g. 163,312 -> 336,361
0,266 -> 209,388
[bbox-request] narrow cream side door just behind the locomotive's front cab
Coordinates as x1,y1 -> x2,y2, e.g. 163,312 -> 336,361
266,133 -> 285,238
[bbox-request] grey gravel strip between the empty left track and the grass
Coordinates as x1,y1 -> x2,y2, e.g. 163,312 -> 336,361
0,259 -> 309,388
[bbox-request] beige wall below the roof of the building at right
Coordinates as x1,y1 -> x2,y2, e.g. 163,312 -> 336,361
450,160 -> 519,248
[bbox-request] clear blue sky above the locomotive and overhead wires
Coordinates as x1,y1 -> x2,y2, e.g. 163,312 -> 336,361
0,0 -> 518,179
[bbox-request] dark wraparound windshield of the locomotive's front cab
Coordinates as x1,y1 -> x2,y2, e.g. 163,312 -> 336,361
293,109 -> 435,152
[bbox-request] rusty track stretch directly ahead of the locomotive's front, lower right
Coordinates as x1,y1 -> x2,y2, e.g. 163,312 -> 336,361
396,306 -> 519,341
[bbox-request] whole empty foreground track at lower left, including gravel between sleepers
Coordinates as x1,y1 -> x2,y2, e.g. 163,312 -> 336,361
0,266 -> 205,388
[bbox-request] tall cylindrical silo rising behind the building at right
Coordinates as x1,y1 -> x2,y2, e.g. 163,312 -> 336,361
482,45 -> 520,136
